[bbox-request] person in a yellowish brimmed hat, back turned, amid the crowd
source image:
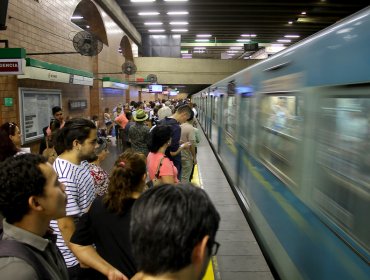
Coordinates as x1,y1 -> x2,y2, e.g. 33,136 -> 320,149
128,109 -> 149,156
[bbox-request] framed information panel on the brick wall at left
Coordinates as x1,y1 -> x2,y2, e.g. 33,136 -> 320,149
19,88 -> 62,144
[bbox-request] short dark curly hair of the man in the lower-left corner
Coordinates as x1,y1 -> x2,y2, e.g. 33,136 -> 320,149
0,154 -> 47,224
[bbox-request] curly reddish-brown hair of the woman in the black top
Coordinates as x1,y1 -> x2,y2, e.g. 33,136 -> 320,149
103,149 -> 146,214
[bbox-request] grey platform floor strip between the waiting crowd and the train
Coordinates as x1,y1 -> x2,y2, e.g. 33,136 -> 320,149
102,130 -> 274,280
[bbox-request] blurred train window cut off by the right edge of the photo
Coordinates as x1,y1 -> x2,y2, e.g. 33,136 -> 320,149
313,97 -> 370,252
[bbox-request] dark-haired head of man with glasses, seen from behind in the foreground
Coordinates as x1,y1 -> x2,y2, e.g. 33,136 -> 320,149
130,184 -> 220,280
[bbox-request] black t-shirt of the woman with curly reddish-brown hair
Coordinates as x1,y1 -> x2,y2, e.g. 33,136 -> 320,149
71,197 -> 137,279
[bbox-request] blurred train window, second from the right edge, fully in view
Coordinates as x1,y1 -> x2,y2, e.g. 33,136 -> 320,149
259,95 -> 303,183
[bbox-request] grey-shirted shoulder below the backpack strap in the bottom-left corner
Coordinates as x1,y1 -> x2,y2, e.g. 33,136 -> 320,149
0,257 -> 38,280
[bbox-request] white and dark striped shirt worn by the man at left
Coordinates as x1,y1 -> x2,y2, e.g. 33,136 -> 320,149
50,157 -> 95,267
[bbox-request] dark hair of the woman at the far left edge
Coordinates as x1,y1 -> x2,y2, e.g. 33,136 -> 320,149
0,122 -> 18,161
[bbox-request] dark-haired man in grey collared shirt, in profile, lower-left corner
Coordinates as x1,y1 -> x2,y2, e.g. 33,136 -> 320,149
0,154 -> 68,280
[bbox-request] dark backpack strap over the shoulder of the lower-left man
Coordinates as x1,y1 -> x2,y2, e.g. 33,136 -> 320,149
0,222 -> 52,280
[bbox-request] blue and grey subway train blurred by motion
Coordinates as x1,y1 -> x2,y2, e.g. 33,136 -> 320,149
192,7 -> 370,280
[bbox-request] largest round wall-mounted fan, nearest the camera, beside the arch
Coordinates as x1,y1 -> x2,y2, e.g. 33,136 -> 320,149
72,31 -> 103,56
